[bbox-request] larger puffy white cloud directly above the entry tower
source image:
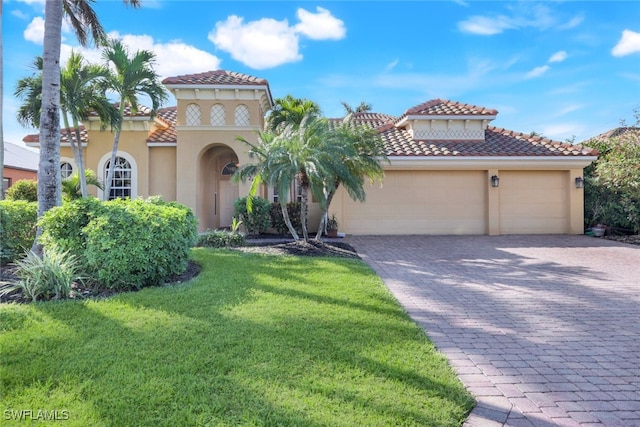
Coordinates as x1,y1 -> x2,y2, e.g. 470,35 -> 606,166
209,15 -> 302,69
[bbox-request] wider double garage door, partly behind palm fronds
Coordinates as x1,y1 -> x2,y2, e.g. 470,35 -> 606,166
341,171 -> 487,235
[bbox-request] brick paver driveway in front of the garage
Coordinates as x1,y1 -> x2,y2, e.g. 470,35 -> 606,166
347,236 -> 640,427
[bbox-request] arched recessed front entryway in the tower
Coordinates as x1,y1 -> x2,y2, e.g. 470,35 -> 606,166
198,145 -> 239,229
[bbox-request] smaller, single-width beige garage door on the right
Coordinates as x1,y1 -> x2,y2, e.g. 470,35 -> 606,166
500,171 -> 569,234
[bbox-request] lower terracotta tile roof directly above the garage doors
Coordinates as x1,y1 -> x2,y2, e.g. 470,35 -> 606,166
380,125 -> 595,157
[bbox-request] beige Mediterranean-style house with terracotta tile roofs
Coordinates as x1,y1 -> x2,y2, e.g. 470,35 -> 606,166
24,70 -> 597,235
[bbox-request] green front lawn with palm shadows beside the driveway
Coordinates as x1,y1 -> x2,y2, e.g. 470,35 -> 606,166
0,248 -> 473,427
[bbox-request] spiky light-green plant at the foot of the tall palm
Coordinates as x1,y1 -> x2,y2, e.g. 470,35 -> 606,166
3,249 -> 82,302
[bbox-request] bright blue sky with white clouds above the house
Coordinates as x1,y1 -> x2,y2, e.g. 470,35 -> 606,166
2,0 -> 640,147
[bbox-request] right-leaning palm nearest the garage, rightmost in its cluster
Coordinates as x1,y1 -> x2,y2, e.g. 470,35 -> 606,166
316,114 -> 389,239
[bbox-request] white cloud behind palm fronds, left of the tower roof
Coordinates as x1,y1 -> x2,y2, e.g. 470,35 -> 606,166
60,32 -> 221,78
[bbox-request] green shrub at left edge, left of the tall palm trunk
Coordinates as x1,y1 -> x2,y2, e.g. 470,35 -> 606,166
0,200 -> 38,264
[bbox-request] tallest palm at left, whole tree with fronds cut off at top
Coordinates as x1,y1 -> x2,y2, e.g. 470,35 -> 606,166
32,0 -> 140,254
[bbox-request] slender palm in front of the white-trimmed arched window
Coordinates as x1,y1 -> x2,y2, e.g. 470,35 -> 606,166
102,40 -> 168,198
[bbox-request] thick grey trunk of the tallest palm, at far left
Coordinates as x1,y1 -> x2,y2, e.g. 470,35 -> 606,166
32,0 -> 62,255
